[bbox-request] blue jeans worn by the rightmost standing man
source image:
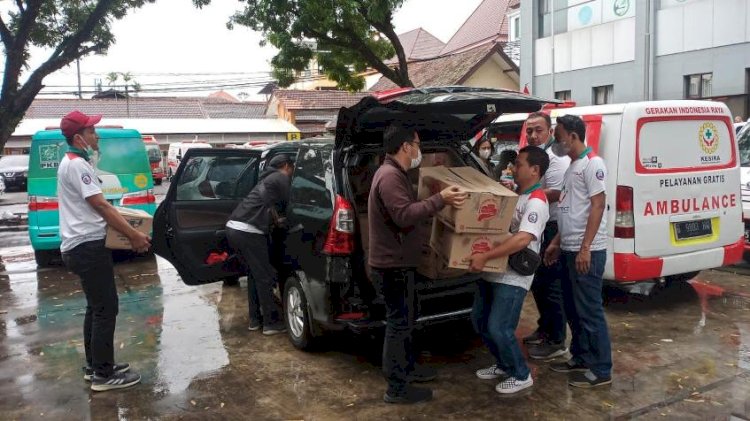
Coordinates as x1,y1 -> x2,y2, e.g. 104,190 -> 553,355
560,250 -> 612,377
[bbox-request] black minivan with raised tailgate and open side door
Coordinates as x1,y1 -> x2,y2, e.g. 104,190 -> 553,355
153,87 -> 547,349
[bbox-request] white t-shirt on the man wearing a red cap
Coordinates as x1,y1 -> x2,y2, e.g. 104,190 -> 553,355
57,154 -> 107,252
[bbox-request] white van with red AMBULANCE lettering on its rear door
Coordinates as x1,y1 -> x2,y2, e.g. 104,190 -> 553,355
493,101 -> 745,285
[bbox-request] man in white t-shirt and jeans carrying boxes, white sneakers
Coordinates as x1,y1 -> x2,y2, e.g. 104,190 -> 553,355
470,146 -> 549,394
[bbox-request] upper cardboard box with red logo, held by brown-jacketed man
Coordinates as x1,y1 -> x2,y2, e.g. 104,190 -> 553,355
417,167 -> 518,234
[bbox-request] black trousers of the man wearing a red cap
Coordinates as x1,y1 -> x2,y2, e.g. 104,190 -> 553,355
62,240 -> 119,377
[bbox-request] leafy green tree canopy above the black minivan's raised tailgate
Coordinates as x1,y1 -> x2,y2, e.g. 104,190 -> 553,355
209,0 -> 414,91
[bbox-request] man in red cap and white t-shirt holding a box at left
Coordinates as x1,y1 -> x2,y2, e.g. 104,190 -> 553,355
57,111 -> 151,391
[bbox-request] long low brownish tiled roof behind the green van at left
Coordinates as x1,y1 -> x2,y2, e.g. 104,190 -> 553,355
25,97 -> 266,118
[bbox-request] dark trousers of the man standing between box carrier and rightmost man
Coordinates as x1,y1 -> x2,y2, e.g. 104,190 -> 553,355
531,222 -> 566,344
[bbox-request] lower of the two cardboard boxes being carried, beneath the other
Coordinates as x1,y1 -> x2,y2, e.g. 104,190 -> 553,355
430,220 -> 512,273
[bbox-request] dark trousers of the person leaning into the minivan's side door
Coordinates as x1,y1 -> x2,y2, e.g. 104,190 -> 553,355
227,228 -> 282,327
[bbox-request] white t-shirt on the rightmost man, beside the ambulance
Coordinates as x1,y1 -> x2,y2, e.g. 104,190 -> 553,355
558,152 -> 607,252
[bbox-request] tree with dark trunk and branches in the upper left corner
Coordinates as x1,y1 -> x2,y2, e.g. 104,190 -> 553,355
0,0 -> 154,150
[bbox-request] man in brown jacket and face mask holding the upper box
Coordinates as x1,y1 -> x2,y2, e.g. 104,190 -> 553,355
368,125 -> 466,403
